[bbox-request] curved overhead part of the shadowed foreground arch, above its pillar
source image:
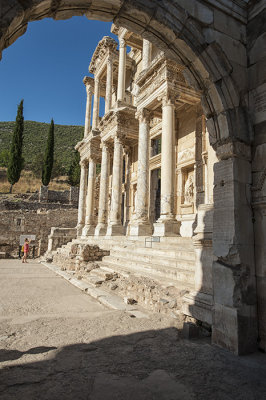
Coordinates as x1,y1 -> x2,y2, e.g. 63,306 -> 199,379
0,0 -> 250,146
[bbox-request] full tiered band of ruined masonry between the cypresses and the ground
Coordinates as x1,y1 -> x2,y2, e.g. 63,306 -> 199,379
0,192 -> 78,258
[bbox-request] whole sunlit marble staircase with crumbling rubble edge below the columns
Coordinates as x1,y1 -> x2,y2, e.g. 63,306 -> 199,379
49,237 -> 195,316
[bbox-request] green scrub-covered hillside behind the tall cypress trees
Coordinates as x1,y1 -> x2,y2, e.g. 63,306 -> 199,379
0,121 -> 84,173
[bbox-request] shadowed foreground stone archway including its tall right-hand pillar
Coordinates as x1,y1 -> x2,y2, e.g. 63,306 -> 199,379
0,0 -> 262,354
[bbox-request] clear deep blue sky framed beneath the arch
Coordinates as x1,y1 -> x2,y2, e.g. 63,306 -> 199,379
0,17 -> 116,125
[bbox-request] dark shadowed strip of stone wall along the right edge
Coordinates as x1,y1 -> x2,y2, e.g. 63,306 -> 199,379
247,0 -> 266,350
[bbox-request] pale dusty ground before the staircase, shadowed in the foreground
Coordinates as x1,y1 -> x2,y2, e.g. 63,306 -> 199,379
0,260 -> 266,400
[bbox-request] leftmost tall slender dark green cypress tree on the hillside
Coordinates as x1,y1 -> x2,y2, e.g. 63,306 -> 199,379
7,100 -> 24,193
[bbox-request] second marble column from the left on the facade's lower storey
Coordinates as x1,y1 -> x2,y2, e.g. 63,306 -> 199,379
82,159 -> 96,236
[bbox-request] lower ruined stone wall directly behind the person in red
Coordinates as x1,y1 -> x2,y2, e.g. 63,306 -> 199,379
0,203 -> 78,257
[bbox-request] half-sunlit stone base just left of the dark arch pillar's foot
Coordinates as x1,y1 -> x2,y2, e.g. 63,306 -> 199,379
182,292 -> 213,325
